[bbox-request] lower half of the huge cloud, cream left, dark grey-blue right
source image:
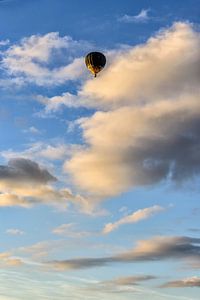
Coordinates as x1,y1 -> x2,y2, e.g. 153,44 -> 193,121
64,96 -> 200,197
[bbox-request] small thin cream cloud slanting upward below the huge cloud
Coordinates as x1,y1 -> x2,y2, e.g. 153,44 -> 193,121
103,205 -> 165,234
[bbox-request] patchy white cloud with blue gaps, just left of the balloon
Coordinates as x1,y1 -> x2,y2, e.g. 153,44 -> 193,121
1,32 -> 91,86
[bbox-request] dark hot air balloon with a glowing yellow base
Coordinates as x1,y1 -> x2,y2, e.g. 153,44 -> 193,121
85,52 -> 106,77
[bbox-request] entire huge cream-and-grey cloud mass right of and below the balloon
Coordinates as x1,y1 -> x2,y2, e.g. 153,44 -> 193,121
64,23 -> 200,198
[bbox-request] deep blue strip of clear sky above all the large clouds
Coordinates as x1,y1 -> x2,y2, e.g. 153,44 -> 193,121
0,0 -> 199,47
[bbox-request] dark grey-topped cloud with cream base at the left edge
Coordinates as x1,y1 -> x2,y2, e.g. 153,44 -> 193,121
0,158 -> 75,208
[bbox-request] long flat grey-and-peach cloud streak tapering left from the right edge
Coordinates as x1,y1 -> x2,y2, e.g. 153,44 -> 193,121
48,237 -> 200,271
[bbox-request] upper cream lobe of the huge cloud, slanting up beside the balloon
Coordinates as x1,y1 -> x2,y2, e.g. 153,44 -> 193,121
80,23 -> 200,108
